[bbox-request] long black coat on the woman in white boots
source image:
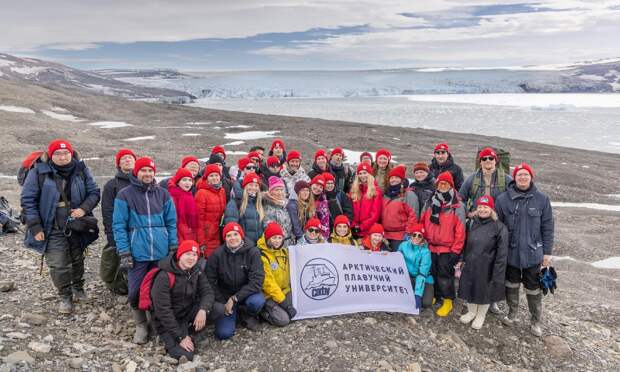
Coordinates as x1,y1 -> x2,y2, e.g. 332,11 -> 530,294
459,217 -> 508,305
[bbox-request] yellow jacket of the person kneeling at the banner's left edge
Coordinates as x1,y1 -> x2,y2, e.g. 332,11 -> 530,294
256,235 -> 291,303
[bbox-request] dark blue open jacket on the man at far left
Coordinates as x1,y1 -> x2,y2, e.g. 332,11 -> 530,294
21,159 -> 100,254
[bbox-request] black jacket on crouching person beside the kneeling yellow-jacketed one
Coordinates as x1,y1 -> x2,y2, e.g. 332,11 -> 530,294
205,239 -> 265,303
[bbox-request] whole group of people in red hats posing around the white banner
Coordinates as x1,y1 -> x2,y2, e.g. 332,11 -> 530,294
21,139 -> 554,359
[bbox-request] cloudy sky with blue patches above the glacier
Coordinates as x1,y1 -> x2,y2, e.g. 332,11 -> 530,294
0,0 -> 620,71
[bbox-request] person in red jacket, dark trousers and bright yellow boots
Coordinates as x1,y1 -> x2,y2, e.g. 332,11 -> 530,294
420,172 -> 465,317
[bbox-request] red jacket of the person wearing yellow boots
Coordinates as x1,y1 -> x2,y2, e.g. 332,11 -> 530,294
420,201 -> 465,254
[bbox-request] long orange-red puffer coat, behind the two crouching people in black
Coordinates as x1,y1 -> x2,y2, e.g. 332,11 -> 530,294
196,182 -> 226,257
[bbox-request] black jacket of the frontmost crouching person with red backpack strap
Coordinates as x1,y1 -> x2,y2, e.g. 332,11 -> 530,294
151,256 -> 213,341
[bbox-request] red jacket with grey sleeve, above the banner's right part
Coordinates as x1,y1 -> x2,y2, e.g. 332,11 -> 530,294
381,190 -> 418,240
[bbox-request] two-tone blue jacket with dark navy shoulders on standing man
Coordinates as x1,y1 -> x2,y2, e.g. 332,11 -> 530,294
112,177 -> 178,262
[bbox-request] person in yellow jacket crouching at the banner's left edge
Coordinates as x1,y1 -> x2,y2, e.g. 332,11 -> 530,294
256,222 -> 297,327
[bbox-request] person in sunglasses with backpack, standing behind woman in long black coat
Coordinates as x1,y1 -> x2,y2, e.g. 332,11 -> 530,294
460,147 -> 512,217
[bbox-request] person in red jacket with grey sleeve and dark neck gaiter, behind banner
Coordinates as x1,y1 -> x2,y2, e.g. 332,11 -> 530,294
381,165 -> 420,252
